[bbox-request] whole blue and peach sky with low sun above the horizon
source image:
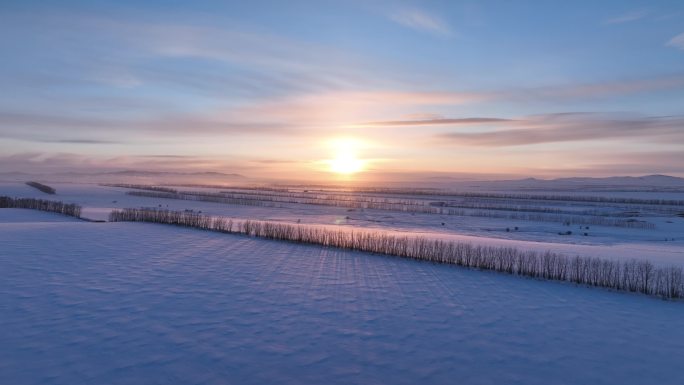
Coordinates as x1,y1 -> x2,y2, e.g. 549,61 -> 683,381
0,0 -> 684,181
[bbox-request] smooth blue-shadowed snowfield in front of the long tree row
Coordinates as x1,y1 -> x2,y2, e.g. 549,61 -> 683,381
0,209 -> 684,385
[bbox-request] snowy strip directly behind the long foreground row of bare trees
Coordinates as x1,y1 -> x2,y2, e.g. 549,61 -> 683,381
0,182 -> 684,265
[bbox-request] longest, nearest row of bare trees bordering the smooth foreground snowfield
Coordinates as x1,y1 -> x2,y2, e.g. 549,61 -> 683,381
109,209 -> 684,298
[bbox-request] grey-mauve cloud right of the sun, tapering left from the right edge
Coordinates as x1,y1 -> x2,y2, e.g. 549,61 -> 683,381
436,113 -> 684,147
